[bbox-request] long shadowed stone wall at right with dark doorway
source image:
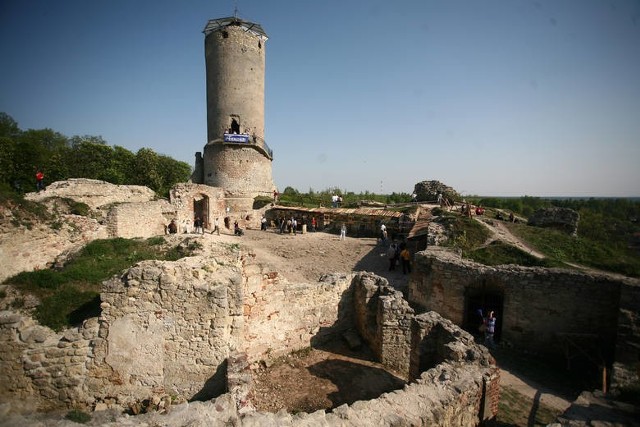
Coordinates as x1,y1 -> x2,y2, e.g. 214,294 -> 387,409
408,249 -> 640,390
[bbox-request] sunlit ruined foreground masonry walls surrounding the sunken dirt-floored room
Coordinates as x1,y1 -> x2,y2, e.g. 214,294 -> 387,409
0,242 -> 499,425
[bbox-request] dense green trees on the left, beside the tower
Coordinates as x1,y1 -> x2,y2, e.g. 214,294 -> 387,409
0,112 -> 191,196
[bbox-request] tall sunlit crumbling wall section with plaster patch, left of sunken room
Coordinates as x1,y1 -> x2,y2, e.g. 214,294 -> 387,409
87,257 -> 242,405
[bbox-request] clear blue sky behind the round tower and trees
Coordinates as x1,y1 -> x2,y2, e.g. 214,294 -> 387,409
0,0 -> 640,196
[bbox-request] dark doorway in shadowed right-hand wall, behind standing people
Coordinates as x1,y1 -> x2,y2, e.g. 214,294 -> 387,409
463,286 -> 504,342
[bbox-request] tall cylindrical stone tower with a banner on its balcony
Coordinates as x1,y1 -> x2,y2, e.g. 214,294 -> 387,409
192,17 -> 275,198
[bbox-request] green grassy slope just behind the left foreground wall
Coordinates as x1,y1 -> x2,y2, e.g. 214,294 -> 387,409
5,237 -> 201,331
